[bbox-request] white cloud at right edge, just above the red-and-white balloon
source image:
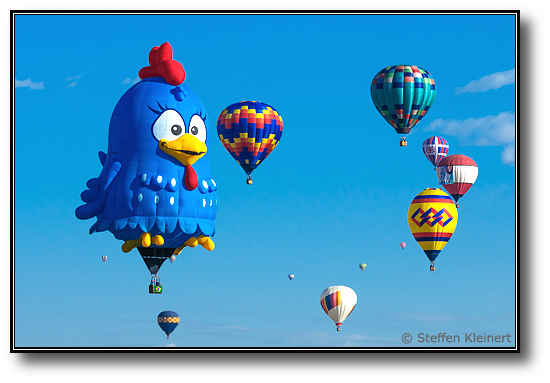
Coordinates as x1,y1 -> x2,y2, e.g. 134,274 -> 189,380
423,112 -> 516,165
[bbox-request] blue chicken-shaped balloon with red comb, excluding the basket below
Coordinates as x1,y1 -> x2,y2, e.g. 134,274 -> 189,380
75,43 -> 218,280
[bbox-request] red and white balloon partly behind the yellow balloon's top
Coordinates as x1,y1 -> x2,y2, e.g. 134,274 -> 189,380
437,154 -> 478,207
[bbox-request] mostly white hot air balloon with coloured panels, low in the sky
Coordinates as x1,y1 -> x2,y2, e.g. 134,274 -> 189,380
321,286 -> 357,331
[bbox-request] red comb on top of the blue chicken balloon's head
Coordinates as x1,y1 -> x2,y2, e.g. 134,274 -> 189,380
139,43 -> 185,85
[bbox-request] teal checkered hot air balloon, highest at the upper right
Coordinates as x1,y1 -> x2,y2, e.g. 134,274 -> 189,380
370,65 -> 436,146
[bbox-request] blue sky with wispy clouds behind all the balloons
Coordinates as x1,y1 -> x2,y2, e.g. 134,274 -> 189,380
14,15 -> 516,347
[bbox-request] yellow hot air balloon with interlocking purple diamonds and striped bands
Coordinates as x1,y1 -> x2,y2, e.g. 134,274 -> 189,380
407,188 -> 458,271
